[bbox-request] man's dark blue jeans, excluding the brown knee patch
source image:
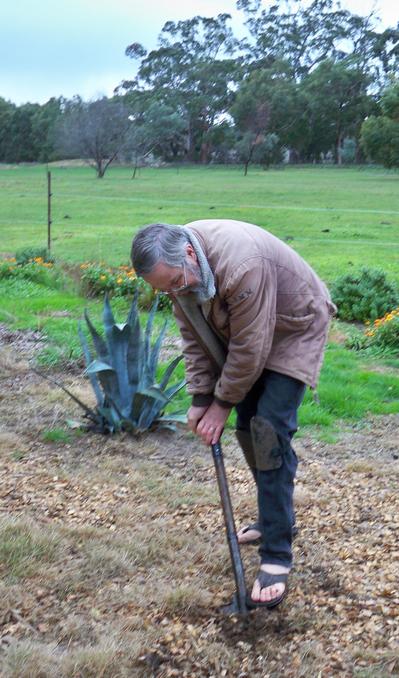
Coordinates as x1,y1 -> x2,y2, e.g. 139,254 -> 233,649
236,370 -> 306,567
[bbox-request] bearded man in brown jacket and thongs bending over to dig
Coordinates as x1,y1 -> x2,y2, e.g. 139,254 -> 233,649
132,219 -> 335,607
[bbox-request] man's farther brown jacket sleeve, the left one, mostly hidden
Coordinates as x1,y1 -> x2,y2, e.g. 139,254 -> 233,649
173,304 -> 218,404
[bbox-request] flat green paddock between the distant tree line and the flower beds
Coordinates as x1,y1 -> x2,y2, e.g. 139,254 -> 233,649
0,166 -> 399,282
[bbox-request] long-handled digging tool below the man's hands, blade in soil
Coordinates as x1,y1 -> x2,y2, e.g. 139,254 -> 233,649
211,441 -> 250,616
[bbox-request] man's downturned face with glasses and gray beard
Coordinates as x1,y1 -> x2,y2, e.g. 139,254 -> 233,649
143,245 -> 201,295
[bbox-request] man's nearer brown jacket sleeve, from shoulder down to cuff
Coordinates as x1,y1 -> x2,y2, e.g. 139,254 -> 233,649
215,257 -> 277,405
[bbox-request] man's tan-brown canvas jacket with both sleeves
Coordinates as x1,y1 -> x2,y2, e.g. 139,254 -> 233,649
174,219 -> 335,405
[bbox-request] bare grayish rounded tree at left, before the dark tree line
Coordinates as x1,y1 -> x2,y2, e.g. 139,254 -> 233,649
58,97 -> 131,179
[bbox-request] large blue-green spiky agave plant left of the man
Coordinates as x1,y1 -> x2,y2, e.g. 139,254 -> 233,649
75,294 -> 185,433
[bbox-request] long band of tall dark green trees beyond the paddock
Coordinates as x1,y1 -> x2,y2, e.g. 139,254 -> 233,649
0,0 -> 399,170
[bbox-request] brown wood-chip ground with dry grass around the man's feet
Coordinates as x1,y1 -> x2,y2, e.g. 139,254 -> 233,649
0,328 -> 399,678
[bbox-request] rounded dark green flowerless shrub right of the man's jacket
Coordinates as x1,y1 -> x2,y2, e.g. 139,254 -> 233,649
331,268 -> 399,322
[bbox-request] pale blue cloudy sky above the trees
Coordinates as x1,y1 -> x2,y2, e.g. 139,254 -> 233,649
0,0 -> 399,104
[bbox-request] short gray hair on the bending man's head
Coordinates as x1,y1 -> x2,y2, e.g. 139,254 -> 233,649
131,224 -> 189,275
